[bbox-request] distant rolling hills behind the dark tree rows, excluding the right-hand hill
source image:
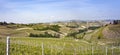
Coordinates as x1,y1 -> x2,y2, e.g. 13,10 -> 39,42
0,21 -> 99,37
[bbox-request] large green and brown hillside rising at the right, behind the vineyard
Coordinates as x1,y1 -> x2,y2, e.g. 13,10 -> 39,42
84,24 -> 120,45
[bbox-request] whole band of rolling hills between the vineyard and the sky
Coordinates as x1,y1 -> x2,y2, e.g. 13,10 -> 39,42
0,21 -> 120,43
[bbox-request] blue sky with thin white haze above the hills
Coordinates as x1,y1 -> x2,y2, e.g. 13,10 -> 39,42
0,0 -> 120,23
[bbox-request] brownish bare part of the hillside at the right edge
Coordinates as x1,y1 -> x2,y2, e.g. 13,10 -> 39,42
103,24 -> 120,42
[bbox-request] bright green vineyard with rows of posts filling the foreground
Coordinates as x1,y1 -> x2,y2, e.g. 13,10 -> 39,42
0,37 -> 120,55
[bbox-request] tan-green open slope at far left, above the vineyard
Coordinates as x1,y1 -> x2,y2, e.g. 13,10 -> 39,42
0,25 -> 47,37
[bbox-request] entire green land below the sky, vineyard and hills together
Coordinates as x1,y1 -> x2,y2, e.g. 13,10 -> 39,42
0,23 -> 120,55
